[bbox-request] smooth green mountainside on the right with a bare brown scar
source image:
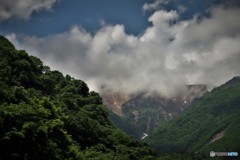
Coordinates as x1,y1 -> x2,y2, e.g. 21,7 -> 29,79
145,77 -> 240,155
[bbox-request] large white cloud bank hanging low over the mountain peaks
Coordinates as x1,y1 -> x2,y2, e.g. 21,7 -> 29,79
5,6 -> 240,96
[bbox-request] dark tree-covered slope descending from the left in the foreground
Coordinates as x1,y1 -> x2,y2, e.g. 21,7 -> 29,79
0,36 -> 155,160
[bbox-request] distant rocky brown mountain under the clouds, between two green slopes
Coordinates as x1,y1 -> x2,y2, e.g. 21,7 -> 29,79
103,84 -> 206,139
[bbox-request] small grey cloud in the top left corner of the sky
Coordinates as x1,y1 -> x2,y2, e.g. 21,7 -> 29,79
0,0 -> 57,22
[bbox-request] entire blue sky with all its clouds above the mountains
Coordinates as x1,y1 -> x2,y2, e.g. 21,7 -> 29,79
0,0 -> 240,96
